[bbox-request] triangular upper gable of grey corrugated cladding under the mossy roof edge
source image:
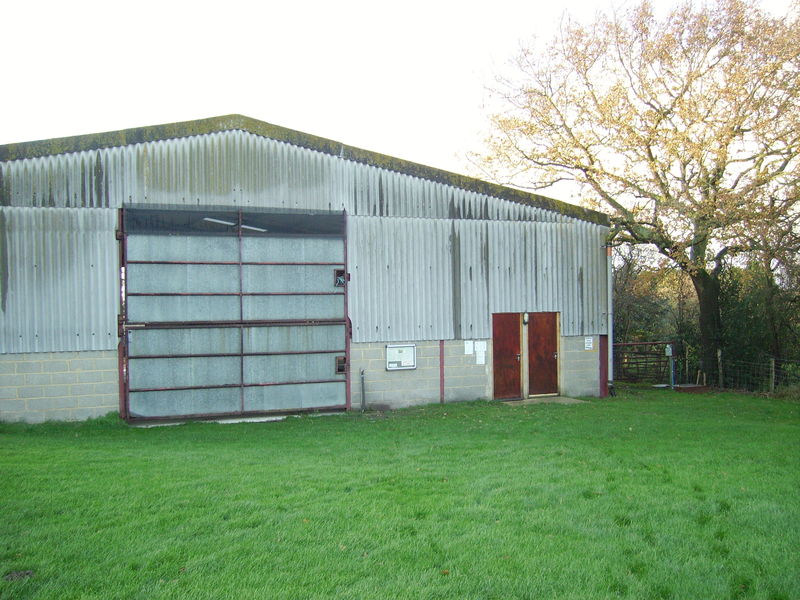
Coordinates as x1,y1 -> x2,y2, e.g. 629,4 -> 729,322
0,131 -> 578,222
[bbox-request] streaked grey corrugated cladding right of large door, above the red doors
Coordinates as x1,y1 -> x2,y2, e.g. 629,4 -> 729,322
348,217 -> 607,342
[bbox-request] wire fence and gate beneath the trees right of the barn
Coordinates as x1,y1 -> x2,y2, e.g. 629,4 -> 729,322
614,342 -> 800,397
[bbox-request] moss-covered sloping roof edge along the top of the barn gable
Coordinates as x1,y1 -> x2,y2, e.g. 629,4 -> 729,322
0,115 -> 609,225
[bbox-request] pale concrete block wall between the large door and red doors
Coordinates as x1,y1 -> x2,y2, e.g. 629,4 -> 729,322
350,340 -> 491,410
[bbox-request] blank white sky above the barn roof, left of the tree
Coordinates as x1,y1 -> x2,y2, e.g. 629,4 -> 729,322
0,0 -> 789,200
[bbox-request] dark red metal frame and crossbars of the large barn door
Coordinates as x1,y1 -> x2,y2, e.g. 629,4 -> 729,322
116,206 -> 352,422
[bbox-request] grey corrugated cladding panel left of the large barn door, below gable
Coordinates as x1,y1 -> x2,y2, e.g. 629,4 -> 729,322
0,208 -> 118,353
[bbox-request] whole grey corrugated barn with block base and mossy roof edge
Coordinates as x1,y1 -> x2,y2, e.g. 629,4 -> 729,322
0,115 -> 611,421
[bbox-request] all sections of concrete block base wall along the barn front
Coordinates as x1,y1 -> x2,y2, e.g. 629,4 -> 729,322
0,336 -> 600,423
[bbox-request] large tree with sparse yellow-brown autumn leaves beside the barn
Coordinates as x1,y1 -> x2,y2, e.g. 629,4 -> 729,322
482,0 -> 800,372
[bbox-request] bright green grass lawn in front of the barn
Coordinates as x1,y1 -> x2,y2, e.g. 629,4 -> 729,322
0,389 -> 800,600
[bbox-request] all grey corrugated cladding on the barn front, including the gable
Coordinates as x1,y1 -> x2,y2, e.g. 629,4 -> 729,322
0,131 -> 607,353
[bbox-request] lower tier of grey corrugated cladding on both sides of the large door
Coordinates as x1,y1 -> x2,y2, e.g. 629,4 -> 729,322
0,208 -> 607,352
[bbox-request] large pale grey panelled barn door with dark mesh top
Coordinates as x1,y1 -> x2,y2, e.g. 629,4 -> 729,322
118,208 -> 349,420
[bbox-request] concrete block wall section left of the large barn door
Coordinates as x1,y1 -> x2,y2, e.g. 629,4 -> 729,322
0,350 -> 119,423
